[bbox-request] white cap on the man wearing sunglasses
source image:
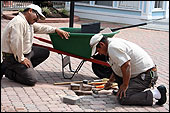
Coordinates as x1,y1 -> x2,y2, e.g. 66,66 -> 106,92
26,4 -> 45,20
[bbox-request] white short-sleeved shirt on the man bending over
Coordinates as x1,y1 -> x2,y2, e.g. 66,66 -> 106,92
108,38 -> 155,78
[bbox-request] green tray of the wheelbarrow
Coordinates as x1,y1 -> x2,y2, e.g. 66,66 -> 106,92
49,28 -> 119,58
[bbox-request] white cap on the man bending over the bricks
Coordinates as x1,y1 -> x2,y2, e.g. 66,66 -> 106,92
90,33 -> 103,56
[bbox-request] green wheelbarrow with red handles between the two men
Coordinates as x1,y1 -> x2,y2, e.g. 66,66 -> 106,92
34,28 -> 119,79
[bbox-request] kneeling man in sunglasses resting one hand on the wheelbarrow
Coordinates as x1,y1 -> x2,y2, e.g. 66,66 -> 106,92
1,4 -> 69,86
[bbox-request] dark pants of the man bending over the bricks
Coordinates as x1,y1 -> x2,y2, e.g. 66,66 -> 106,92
115,71 -> 157,106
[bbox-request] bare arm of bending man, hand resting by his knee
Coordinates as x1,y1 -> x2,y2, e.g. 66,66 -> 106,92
117,60 -> 131,98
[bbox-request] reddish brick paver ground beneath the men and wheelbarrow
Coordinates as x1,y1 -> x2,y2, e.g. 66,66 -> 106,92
1,19 -> 169,112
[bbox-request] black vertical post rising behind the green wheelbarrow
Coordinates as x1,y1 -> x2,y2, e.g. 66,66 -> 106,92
69,1 -> 74,27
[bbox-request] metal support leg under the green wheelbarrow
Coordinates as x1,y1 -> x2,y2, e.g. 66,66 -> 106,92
61,54 -> 85,79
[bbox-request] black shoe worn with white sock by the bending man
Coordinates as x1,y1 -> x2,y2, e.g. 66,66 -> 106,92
156,85 -> 167,105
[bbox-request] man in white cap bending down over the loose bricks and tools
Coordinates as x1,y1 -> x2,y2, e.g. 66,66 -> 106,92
90,33 -> 167,106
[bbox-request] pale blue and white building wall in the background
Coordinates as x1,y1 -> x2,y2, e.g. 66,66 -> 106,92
66,1 -> 169,24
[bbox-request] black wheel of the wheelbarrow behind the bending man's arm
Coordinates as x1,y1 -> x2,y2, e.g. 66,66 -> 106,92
92,54 -> 113,79
